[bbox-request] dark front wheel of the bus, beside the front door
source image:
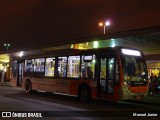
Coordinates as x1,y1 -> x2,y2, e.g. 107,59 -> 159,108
78,85 -> 91,102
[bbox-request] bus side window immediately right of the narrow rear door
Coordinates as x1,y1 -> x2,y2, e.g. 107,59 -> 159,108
25,59 -> 34,72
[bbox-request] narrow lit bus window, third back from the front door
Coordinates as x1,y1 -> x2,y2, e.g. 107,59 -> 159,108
58,57 -> 67,77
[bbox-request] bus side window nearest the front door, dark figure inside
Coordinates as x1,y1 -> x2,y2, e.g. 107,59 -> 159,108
81,55 -> 95,79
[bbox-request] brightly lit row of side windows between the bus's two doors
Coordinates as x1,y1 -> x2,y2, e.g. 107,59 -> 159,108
25,55 -> 95,78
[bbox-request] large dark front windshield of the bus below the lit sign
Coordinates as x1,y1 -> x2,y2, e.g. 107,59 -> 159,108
122,56 -> 147,86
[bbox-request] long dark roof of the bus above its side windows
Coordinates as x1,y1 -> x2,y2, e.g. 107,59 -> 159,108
11,46 -> 142,60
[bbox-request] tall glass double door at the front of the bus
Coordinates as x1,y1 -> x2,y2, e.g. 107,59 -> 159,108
98,57 -> 115,97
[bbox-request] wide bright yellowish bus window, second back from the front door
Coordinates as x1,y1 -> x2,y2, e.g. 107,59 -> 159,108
67,56 -> 80,78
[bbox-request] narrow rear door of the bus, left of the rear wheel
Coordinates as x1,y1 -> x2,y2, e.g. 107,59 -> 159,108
17,62 -> 24,86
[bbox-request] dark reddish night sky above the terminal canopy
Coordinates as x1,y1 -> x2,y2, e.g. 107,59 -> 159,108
0,0 -> 160,49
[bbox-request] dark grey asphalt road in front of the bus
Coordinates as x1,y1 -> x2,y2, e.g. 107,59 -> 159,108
0,86 -> 160,120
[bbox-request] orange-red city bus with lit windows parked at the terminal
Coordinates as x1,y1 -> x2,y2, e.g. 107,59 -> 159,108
10,46 -> 148,101
